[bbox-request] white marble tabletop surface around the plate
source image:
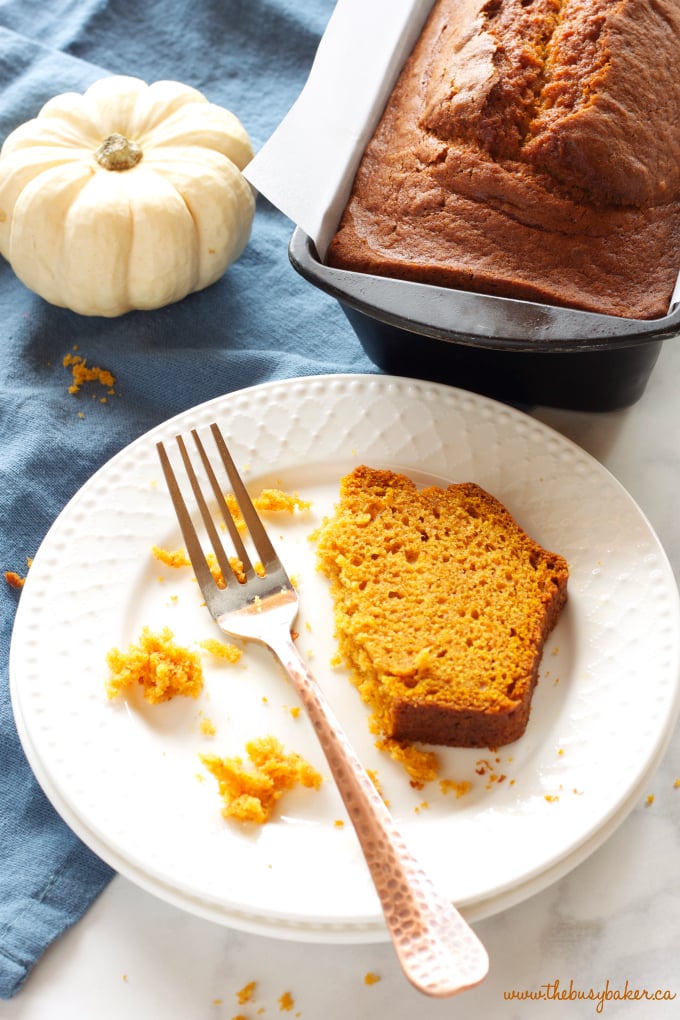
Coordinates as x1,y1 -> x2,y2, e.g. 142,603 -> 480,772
0,341 -> 680,1020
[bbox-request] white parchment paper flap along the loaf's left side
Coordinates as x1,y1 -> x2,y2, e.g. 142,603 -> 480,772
244,0 -> 433,258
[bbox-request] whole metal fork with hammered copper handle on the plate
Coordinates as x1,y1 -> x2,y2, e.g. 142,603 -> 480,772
157,424 -> 488,998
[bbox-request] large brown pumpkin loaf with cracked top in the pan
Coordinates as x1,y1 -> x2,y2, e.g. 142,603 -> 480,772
327,0 -> 680,318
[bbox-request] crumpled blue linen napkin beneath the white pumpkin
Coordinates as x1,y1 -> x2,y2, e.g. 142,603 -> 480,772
0,0 -> 375,999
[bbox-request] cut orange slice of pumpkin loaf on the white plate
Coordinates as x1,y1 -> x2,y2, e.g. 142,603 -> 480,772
318,466 -> 568,748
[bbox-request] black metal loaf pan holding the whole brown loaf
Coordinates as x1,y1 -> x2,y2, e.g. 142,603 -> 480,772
289,227 -> 680,411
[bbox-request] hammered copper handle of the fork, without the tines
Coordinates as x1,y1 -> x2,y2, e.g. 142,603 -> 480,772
268,628 -> 488,998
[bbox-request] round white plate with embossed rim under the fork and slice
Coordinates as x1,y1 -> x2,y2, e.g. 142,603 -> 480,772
10,375 -> 680,941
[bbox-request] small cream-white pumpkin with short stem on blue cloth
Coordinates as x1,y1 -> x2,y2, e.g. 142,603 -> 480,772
0,75 -> 255,316
